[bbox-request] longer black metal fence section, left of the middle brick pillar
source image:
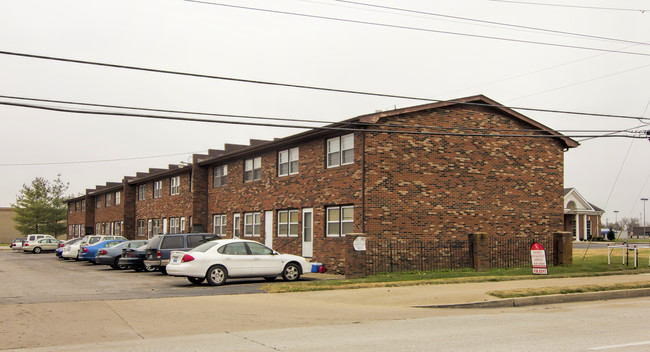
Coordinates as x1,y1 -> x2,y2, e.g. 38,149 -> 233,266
366,238 -> 472,275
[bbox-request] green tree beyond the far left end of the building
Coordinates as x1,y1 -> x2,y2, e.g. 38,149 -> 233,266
11,175 -> 68,237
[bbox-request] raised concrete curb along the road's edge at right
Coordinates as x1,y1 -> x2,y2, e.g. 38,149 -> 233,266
413,288 -> 650,308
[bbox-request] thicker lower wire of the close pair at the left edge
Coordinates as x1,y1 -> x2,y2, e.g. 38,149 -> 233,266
0,101 -> 646,138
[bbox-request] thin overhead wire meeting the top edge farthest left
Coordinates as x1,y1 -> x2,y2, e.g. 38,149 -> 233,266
180,0 -> 650,56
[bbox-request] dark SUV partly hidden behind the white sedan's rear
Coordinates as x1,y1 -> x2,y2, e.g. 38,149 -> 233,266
144,233 -> 221,274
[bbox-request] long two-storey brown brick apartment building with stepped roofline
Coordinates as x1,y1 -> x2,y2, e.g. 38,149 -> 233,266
68,96 -> 578,267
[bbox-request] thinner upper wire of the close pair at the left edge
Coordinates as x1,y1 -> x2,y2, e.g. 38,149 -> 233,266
0,95 -> 638,133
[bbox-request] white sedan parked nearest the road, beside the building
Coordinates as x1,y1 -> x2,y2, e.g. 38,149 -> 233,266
167,239 -> 311,286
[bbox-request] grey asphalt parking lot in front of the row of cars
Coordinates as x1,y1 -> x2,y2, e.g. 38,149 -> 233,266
0,250 -> 281,304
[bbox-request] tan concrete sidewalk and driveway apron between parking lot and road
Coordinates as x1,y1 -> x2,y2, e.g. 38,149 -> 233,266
0,274 -> 650,349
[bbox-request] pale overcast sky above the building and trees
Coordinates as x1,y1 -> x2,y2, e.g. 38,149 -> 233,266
0,0 -> 650,226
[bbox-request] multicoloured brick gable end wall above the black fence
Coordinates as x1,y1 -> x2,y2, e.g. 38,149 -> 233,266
365,107 -> 564,239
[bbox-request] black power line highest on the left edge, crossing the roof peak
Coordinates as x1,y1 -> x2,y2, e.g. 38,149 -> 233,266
0,48 -> 645,120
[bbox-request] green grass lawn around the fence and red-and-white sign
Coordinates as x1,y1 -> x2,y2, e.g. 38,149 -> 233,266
262,249 -> 650,297
